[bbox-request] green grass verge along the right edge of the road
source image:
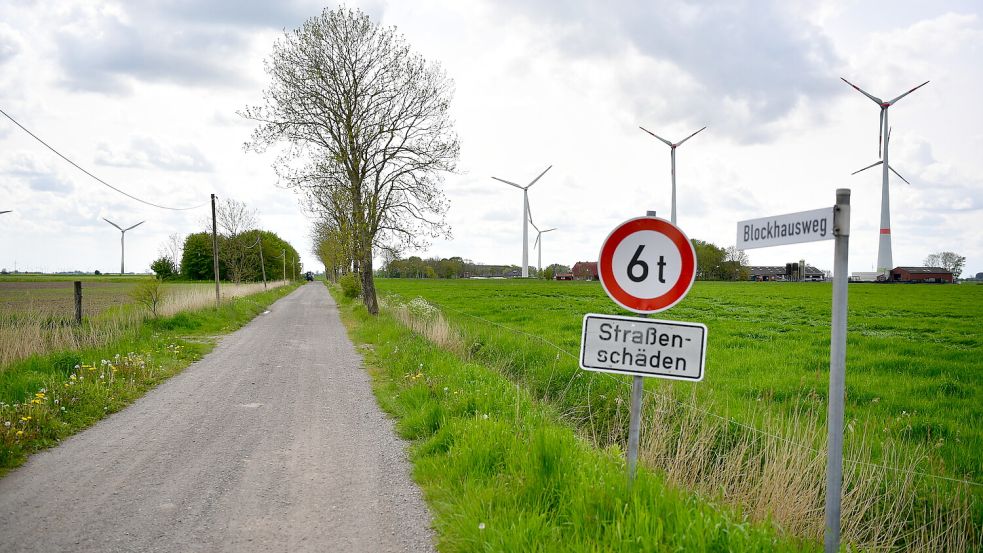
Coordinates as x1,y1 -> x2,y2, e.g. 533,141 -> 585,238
333,284 -> 818,552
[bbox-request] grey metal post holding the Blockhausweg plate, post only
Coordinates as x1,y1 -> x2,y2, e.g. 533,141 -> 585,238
825,188 -> 850,553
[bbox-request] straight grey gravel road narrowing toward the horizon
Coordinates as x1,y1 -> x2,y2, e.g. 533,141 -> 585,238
0,282 -> 433,553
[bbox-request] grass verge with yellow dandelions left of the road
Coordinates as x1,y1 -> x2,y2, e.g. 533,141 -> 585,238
0,286 -> 296,475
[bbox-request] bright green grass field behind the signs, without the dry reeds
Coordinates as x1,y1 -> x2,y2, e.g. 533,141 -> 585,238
379,279 -> 983,481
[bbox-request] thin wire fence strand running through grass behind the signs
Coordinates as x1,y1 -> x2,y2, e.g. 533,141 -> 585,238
396,300 -> 983,487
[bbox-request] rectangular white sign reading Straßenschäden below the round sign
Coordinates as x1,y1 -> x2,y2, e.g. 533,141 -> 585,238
580,313 -> 707,381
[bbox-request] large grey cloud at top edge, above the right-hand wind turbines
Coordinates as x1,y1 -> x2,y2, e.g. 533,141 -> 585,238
492,0 -> 846,142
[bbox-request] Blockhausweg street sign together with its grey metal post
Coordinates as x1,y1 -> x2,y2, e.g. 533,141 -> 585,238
737,188 -> 850,553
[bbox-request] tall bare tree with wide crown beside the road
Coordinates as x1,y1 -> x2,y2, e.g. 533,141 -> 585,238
241,8 -> 460,314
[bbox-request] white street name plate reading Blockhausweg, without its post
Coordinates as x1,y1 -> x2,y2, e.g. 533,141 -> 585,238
737,207 -> 833,250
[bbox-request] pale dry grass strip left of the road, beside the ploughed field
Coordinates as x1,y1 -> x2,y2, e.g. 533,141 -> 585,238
0,281 -> 287,367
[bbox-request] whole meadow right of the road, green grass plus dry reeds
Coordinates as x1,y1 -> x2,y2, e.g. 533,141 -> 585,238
370,279 -> 983,550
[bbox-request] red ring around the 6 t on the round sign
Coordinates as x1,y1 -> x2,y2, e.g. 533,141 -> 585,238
597,217 -> 696,313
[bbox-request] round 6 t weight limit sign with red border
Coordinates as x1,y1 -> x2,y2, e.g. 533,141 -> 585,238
597,217 -> 696,313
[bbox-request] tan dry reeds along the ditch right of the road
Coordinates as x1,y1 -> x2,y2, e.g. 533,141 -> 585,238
382,298 -> 983,552
